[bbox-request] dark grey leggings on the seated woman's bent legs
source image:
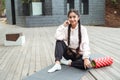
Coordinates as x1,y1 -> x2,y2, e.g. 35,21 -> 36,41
55,40 -> 85,69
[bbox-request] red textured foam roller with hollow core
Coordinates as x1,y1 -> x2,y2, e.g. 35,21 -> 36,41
91,56 -> 113,68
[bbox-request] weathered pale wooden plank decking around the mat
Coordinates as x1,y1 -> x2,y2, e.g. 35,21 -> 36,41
0,23 -> 120,80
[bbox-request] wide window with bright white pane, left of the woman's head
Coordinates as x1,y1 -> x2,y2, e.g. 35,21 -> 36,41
31,0 -> 52,16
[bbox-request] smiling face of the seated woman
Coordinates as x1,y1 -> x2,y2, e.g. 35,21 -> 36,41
68,12 -> 80,27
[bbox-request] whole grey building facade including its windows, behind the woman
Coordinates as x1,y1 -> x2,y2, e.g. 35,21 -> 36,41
6,0 -> 105,27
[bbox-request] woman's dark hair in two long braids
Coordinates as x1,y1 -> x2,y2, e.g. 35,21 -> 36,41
67,9 -> 82,54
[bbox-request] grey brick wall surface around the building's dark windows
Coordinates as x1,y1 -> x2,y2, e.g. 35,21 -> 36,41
7,0 -> 105,27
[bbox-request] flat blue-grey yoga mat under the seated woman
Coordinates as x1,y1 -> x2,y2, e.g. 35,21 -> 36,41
23,54 -> 107,80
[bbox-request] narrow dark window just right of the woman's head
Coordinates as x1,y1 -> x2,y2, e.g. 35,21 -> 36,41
81,0 -> 89,15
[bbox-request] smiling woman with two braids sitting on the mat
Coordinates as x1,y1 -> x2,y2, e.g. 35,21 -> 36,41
48,9 -> 91,72
